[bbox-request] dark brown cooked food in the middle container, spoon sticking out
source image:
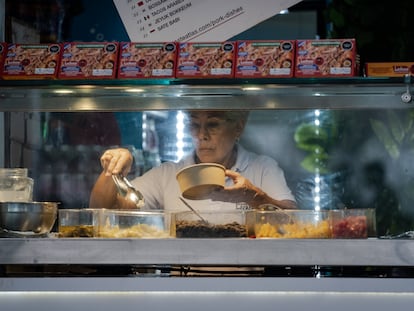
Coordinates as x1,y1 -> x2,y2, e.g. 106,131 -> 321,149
175,220 -> 247,238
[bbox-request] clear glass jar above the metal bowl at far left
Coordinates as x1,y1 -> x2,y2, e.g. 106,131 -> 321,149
0,168 -> 33,202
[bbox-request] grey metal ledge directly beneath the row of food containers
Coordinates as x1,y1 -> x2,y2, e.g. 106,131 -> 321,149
0,238 -> 414,266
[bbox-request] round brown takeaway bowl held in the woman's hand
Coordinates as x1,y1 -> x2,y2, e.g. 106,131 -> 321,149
177,163 -> 226,200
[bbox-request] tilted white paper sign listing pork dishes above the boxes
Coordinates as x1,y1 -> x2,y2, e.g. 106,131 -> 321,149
114,0 -> 300,42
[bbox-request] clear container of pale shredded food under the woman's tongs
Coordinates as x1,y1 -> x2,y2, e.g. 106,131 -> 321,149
98,210 -> 170,238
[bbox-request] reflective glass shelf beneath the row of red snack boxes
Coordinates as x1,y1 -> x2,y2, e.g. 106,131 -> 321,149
0,77 -> 413,112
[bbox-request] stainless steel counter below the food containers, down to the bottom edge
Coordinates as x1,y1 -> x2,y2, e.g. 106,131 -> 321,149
0,234 -> 414,311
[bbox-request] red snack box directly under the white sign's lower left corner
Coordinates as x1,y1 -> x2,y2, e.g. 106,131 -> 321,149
118,42 -> 177,79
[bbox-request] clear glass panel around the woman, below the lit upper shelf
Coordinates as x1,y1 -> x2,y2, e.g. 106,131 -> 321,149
10,109 -> 414,235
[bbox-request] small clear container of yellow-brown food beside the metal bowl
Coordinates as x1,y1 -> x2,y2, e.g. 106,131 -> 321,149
58,208 -> 102,238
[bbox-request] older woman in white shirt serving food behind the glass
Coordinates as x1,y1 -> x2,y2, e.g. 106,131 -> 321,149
89,111 -> 296,211
